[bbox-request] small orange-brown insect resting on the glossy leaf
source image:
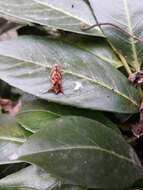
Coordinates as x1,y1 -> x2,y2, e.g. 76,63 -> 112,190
48,64 -> 63,94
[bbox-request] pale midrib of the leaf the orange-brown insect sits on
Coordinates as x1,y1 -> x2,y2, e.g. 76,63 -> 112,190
0,54 -> 139,107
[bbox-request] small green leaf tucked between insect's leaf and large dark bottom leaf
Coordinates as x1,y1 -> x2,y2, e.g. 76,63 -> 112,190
16,98 -> 120,133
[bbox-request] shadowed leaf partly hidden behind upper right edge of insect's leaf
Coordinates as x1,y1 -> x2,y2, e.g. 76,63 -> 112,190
63,34 -> 123,68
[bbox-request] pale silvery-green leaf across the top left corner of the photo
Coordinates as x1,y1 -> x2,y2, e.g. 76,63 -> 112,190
0,0 -> 103,36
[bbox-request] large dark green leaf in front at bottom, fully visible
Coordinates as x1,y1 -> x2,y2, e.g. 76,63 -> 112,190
12,116 -> 142,189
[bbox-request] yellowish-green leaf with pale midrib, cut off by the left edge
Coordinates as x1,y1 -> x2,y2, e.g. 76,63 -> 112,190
0,114 -> 29,164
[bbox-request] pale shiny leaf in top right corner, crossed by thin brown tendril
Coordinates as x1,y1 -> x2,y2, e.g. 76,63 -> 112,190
90,0 -> 143,69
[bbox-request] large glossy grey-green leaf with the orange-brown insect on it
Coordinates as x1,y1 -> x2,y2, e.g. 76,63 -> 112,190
0,36 -> 140,113
